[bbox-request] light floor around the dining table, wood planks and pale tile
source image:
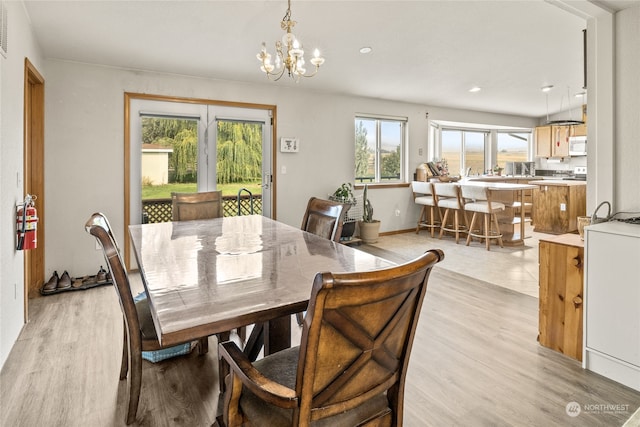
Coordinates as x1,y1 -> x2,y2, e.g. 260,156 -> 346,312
0,227 -> 640,427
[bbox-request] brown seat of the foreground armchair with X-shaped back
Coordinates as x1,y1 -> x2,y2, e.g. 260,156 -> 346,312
240,347 -> 391,427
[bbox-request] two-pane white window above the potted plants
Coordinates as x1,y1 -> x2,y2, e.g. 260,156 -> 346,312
355,117 -> 407,184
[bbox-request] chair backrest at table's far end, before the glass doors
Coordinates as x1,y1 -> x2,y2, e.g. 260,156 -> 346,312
171,191 -> 223,221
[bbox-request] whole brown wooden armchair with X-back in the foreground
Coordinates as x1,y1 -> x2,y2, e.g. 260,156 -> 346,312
216,249 -> 444,427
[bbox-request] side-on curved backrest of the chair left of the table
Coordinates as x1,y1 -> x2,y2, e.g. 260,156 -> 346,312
84,212 -> 142,349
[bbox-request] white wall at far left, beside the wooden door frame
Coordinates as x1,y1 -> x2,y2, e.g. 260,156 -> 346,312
0,1 -> 42,364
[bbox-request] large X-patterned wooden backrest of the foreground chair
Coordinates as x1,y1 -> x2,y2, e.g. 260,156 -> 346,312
294,249 -> 444,425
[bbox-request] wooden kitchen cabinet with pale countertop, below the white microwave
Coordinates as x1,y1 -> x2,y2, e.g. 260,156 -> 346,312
531,181 -> 587,234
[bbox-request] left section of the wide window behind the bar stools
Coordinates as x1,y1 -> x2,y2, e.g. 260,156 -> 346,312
441,129 -> 487,175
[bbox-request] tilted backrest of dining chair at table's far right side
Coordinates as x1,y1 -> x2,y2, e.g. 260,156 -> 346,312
300,197 -> 347,242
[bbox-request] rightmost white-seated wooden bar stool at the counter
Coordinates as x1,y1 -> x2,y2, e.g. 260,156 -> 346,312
460,184 -> 505,251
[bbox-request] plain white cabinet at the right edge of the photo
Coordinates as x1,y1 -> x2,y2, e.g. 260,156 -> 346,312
582,221 -> 640,391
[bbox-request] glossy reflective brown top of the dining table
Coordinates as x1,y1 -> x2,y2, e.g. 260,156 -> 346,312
129,215 -> 394,345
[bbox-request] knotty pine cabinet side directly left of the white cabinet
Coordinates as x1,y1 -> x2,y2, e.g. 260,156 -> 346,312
538,234 -> 584,361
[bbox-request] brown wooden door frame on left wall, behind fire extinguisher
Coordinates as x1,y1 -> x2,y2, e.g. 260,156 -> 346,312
23,58 -> 46,310
